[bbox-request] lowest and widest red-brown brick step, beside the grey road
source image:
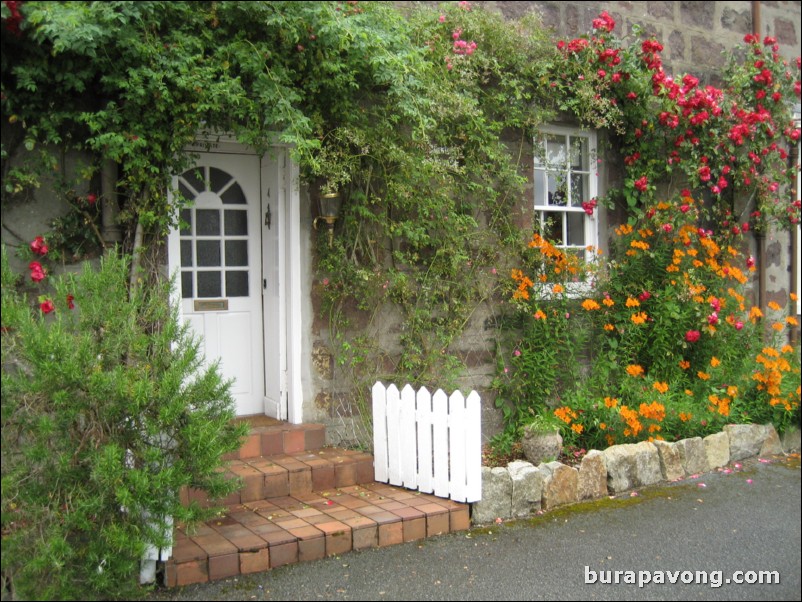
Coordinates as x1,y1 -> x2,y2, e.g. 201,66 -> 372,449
165,482 -> 470,587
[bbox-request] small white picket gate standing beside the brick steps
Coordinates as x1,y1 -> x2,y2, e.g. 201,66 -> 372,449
373,382 -> 482,502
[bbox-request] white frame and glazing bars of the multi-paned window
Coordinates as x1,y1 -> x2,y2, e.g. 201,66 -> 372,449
533,125 -> 599,262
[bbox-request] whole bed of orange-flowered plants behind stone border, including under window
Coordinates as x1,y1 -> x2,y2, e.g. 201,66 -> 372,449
496,191 -> 800,449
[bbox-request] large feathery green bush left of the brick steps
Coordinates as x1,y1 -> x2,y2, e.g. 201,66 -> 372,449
2,246 -> 243,599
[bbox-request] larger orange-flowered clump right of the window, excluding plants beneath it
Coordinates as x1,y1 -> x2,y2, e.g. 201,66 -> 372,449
564,191 -> 800,448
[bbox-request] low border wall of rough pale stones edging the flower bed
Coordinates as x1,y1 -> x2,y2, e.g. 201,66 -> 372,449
471,424 -> 799,524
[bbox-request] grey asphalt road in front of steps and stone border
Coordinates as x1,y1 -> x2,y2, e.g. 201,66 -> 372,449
150,455 -> 802,600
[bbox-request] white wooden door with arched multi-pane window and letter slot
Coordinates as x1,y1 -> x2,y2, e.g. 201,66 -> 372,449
170,153 -> 268,416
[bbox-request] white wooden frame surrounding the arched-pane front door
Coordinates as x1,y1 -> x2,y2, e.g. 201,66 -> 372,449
168,135 -> 303,424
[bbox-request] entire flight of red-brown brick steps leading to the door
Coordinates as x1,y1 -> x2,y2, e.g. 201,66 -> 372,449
164,417 -> 470,587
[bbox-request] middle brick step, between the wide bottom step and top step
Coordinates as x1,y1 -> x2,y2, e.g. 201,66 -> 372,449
181,447 -> 373,507
